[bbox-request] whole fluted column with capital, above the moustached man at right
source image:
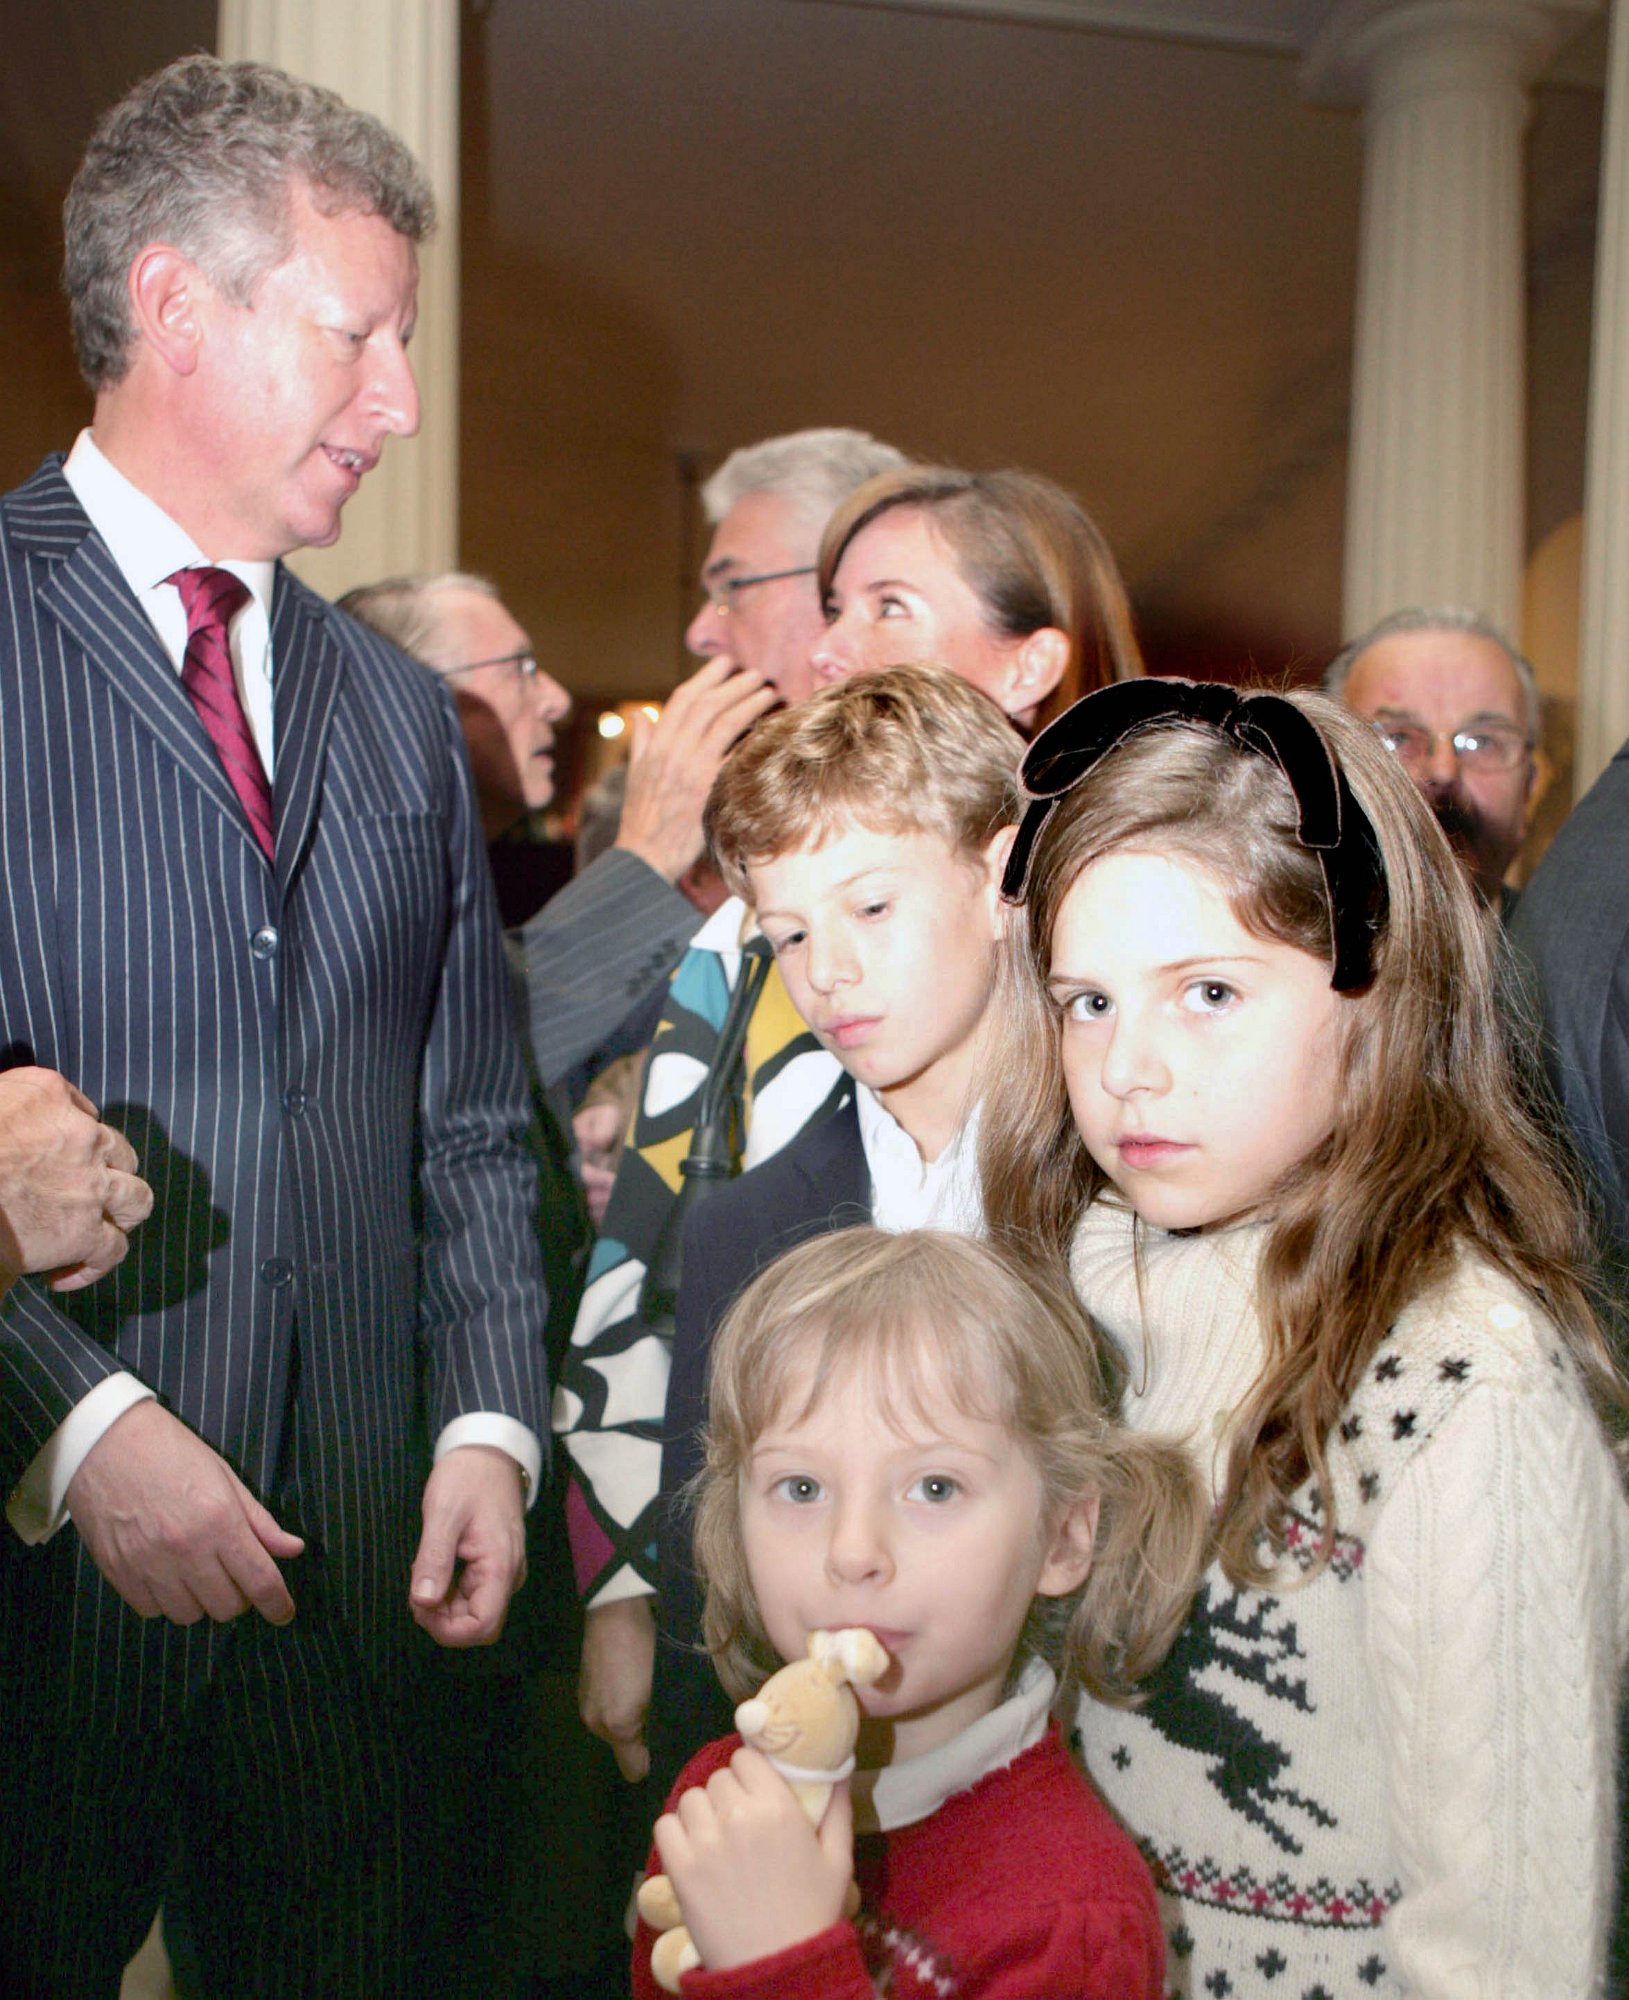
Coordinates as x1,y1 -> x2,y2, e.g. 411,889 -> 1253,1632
1305,0 -> 1599,634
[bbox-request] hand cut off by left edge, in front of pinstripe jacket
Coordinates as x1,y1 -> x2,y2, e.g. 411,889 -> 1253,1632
0,1070 -> 152,1292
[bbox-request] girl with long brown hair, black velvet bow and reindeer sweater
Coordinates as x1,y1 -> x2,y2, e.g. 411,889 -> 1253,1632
983,680 -> 1629,2000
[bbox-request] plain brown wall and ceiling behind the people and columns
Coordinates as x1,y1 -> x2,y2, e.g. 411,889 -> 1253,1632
0,0 -> 1603,694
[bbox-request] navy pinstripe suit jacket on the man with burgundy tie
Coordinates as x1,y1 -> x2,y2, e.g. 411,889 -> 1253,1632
0,460 -> 546,1678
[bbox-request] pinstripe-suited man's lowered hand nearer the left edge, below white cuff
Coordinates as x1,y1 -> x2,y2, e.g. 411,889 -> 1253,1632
68,1402 -> 306,1624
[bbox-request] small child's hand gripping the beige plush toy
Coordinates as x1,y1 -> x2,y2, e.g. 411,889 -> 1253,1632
656,1748 -> 855,1972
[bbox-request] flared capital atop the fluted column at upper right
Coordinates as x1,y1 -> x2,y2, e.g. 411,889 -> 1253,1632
1301,0 -> 1605,104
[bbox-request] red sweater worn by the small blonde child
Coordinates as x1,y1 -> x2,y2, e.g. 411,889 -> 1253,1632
632,1724 -> 1165,2000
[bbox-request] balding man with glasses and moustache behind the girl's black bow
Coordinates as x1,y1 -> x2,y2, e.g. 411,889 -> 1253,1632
1323,610 -> 1539,918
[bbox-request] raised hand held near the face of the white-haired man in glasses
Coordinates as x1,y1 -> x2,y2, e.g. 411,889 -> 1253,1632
616,654 -> 780,882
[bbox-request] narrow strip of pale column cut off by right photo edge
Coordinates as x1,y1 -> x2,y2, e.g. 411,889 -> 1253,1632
1573,0 -> 1629,798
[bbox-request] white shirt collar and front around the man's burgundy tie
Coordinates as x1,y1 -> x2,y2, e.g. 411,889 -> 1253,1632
62,430 -> 276,778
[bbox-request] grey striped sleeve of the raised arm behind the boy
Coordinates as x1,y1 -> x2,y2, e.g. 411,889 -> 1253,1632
520,848 -> 700,1086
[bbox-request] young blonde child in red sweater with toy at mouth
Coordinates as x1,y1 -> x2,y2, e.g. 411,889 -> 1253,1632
634,1228 -> 1205,2000
